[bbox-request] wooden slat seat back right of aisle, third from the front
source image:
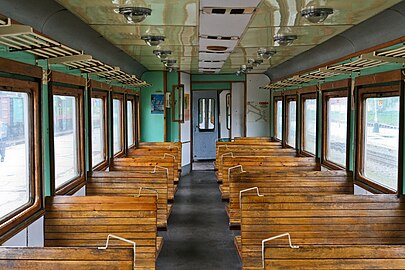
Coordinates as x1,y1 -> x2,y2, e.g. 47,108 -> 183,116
228,170 -> 354,227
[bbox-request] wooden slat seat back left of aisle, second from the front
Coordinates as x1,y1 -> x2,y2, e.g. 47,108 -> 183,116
44,195 -> 157,269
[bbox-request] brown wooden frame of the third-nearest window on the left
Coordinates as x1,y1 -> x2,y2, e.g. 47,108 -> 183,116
89,89 -> 109,171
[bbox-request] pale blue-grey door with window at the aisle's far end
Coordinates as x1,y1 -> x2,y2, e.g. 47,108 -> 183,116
193,91 -> 218,160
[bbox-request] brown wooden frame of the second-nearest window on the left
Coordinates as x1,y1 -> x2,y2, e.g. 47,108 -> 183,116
49,85 -> 86,195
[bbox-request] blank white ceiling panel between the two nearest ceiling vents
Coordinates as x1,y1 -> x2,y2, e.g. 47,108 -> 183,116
200,14 -> 252,37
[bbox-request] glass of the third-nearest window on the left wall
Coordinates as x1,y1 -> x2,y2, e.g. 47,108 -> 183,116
91,98 -> 106,166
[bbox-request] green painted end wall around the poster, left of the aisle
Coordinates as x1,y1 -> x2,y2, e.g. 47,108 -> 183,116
140,71 -> 164,142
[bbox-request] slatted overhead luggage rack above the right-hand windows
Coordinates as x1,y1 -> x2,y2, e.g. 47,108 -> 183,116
262,43 -> 405,90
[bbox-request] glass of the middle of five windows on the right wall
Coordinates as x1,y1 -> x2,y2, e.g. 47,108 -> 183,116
304,99 -> 316,155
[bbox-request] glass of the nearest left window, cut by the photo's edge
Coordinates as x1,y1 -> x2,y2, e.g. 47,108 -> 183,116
0,91 -> 33,218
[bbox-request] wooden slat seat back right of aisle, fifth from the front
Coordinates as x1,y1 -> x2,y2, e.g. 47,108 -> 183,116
215,147 -> 297,181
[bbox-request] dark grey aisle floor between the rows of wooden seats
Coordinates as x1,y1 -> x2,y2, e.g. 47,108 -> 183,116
157,171 -> 241,270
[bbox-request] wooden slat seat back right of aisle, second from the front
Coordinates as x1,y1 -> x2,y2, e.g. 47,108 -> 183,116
241,194 -> 405,269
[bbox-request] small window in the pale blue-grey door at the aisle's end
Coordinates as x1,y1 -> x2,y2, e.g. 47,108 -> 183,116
198,98 -> 215,131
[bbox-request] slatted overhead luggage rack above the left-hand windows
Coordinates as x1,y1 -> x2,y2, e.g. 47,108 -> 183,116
0,19 -> 150,87
